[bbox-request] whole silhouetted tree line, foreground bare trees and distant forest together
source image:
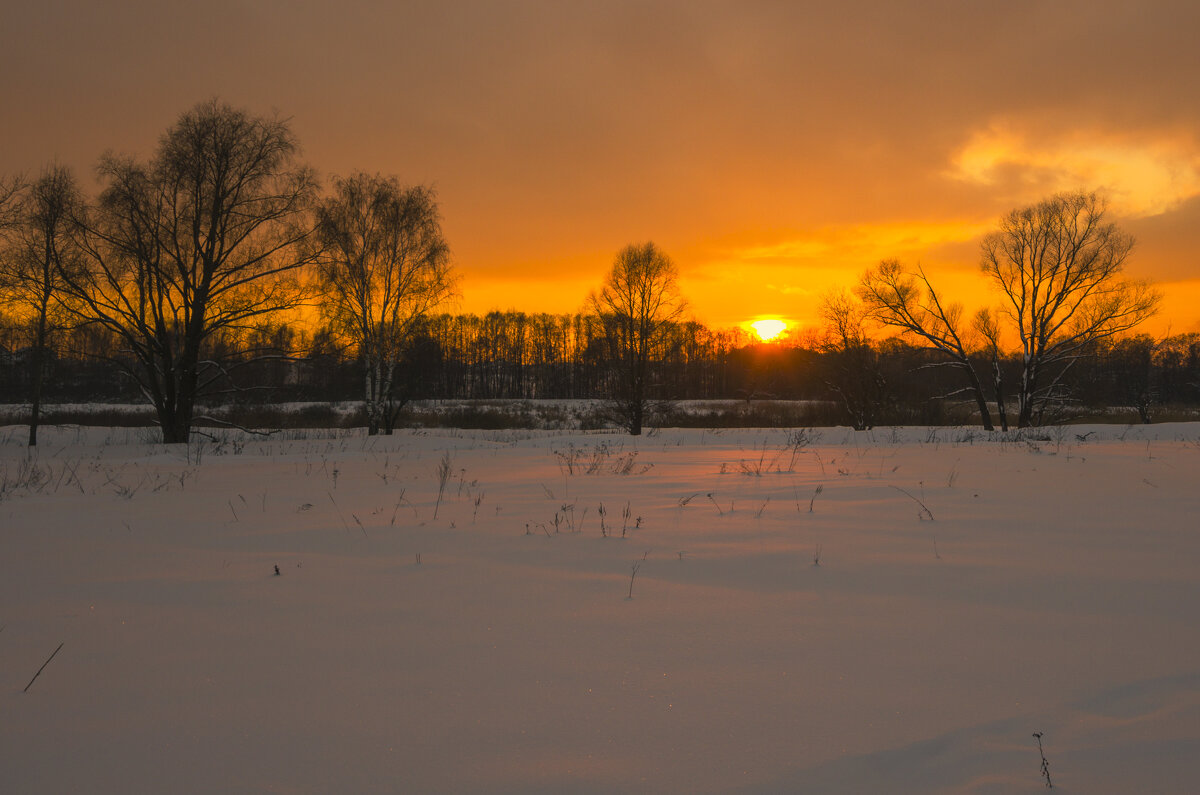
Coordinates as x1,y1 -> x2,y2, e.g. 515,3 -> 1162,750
0,100 -> 1176,444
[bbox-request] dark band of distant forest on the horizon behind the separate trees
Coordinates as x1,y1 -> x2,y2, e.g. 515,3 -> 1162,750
0,312 -> 1200,425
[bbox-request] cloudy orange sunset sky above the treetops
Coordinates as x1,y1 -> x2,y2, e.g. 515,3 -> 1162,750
0,0 -> 1200,333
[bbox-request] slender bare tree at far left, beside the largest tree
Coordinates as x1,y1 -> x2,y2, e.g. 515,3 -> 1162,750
0,166 -> 83,447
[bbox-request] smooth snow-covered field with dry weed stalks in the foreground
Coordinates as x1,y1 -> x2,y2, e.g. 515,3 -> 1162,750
0,424 -> 1200,794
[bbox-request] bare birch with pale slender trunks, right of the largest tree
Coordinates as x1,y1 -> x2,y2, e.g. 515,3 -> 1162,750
317,173 -> 455,435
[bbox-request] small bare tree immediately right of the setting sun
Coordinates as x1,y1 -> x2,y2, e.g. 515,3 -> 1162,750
818,292 -> 888,431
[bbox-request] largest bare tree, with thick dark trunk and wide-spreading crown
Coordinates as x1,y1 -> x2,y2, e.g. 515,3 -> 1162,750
67,100 -> 317,443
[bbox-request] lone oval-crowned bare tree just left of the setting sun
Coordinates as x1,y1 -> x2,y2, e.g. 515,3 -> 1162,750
588,243 -> 688,436
